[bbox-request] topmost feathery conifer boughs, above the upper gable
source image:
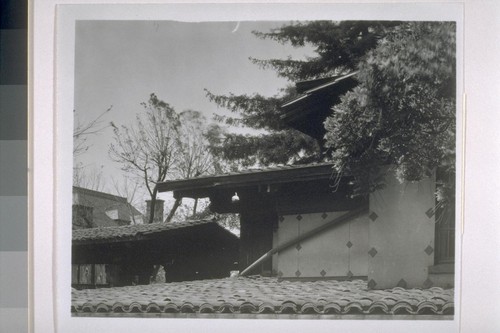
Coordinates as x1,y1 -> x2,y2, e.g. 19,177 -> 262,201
252,21 -> 401,81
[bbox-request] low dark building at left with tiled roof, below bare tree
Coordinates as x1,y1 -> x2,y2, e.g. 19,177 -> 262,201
72,220 -> 238,289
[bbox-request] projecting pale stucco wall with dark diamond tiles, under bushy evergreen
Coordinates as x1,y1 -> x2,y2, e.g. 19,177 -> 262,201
367,169 -> 435,289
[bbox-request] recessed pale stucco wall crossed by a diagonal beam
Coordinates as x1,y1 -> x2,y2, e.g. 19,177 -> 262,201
273,212 -> 369,278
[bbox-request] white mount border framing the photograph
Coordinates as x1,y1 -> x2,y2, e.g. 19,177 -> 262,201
32,1 -> 463,332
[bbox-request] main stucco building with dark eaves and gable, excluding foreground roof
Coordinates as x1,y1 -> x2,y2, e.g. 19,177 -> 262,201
158,74 -> 454,289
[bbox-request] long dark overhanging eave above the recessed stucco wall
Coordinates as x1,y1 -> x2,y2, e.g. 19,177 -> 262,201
158,163 -> 333,197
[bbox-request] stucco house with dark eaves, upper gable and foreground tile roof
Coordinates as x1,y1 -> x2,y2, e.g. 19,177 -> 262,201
71,75 -> 454,320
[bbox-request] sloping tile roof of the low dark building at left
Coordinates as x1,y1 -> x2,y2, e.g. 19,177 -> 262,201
72,220 -> 223,243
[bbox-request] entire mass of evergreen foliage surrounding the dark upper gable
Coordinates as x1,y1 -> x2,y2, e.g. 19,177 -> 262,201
207,21 -> 456,205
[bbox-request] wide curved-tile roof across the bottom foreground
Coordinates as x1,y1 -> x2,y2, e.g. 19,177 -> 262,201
71,276 -> 454,318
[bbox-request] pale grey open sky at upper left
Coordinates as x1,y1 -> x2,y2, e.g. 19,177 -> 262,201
74,21 -> 312,210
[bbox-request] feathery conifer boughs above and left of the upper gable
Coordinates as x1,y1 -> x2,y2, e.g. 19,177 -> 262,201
203,21 -> 400,167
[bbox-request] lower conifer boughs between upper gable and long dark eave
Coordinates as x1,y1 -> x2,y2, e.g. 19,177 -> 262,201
207,83 -> 320,169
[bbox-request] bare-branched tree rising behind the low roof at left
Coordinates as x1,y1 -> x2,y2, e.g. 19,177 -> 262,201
109,94 -> 226,222
